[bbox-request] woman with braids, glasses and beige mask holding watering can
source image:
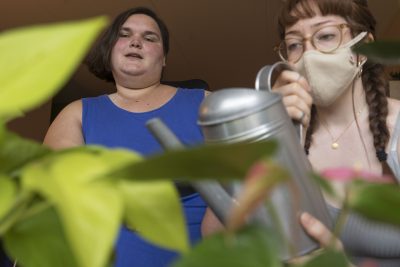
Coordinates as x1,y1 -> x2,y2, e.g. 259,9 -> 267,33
274,0 -> 400,266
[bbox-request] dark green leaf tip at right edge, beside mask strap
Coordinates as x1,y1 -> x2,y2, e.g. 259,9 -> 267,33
355,41 -> 400,65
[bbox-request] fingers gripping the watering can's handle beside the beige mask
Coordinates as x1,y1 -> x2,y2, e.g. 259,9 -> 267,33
273,71 -> 312,127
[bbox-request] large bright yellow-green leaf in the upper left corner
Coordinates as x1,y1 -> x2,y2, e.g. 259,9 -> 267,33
0,14 -> 107,118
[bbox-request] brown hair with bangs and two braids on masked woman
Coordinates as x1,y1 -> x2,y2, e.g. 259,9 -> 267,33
278,0 -> 390,170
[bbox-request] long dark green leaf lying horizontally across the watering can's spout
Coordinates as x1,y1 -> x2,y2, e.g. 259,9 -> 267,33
113,141 -> 277,180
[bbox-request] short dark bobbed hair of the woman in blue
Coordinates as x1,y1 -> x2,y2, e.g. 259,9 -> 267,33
85,7 -> 169,82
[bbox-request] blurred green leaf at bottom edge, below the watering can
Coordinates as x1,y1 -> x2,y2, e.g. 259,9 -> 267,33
173,226 -> 283,267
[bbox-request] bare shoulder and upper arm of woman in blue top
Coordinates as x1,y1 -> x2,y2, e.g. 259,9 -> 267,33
43,100 -> 84,149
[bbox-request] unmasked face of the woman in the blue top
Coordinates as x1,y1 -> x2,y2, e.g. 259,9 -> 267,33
111,14 -> 165,81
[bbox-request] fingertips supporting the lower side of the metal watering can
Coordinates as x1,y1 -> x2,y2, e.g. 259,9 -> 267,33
300,212 -> 343,250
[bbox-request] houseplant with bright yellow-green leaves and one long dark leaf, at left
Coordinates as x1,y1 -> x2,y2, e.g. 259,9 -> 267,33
0,17 -> 284,267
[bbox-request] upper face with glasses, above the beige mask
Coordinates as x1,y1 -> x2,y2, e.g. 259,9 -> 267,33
285,9 -> 352,63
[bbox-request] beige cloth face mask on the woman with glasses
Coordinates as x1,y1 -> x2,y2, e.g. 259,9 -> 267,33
295,32 -> 367,106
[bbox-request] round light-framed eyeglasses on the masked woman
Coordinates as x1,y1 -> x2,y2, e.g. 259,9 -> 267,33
274,24 -> 349,62
